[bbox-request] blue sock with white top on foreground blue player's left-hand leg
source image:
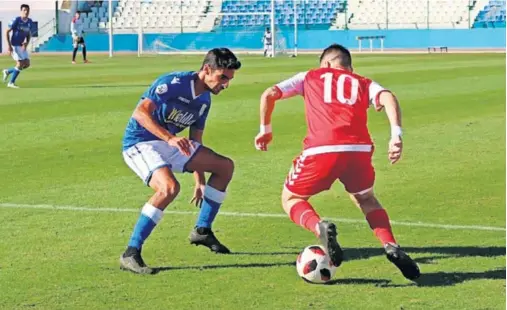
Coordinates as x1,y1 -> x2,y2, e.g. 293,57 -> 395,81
129,203 -> 164,250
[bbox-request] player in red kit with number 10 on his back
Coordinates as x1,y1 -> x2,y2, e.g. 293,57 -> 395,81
255,44 -> 420,280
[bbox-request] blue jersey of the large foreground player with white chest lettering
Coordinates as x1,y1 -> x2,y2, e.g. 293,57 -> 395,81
123,71 -> 211,150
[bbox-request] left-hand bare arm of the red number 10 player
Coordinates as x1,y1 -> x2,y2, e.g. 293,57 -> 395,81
255,86 -> 282,151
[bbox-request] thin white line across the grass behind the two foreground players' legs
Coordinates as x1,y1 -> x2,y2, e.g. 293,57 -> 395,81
0,203 -> 506,231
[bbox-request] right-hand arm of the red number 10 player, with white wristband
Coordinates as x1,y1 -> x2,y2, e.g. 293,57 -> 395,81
379,92 -> 403,164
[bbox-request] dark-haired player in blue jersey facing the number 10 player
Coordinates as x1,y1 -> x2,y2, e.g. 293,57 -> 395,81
120,48 -> 241,274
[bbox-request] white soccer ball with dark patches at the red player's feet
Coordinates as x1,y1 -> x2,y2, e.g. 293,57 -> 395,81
296,245 -> 336,284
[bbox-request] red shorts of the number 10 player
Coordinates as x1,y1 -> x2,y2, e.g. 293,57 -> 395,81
285,151 -> 375,196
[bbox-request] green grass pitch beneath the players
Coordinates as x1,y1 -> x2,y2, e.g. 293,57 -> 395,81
0,53 -> 506,309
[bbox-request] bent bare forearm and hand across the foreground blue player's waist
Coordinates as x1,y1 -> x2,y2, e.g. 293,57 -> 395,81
132,98 -> 193,156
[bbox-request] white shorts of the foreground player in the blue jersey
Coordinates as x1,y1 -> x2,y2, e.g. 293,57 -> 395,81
123,140 -> 201,185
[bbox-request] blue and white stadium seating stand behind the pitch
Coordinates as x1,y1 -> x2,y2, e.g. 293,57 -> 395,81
75,0 -> 506,33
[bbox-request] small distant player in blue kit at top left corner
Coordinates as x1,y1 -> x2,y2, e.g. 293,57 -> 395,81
2,4 -> 33,88
